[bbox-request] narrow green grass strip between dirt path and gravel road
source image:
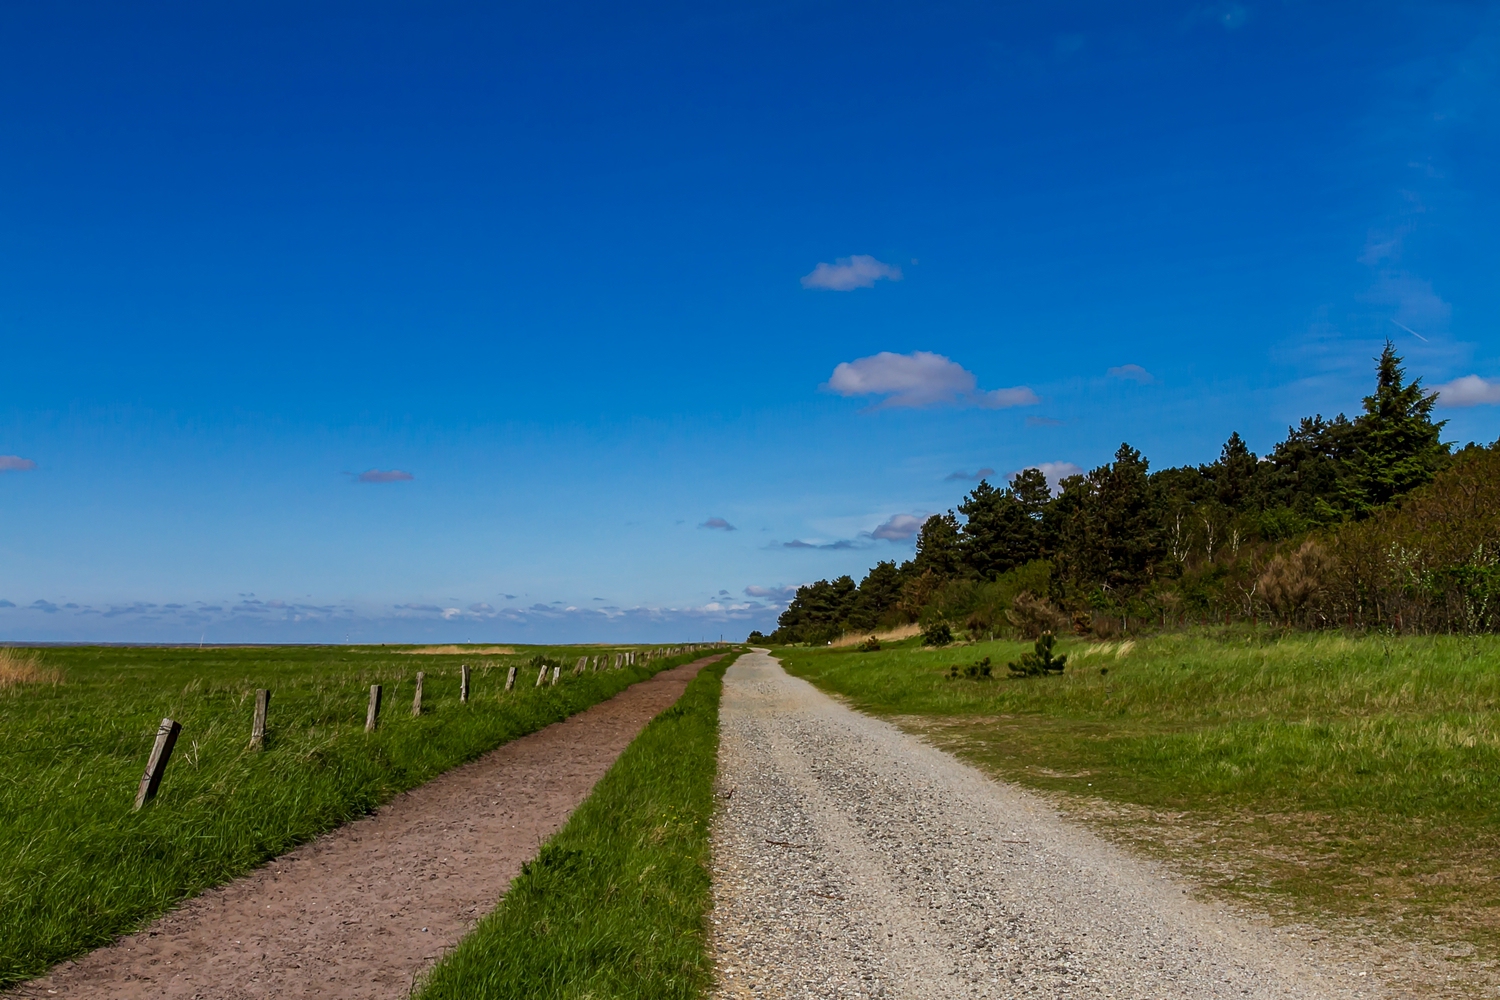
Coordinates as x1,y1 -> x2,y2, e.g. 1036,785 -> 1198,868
420,644 -> 734,1000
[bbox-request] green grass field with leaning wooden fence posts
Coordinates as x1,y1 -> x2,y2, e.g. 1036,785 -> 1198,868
0,646 -> 704,987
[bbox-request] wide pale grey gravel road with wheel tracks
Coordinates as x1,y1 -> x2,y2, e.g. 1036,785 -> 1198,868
713,654 -> 1382,1000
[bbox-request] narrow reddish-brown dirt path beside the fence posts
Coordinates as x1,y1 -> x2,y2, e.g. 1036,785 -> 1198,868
6,657 -> 717,1000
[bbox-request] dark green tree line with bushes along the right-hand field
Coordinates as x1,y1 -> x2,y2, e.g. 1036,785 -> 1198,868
762,342 -> 1500,643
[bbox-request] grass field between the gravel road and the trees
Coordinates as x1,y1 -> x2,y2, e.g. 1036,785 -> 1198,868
777,631 -> 1500,957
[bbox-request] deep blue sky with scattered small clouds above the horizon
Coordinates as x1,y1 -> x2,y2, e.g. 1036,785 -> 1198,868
0,1 -> 1500,642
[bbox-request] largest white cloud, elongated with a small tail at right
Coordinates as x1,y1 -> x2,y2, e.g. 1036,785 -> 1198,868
824,351 -> 1041,409
